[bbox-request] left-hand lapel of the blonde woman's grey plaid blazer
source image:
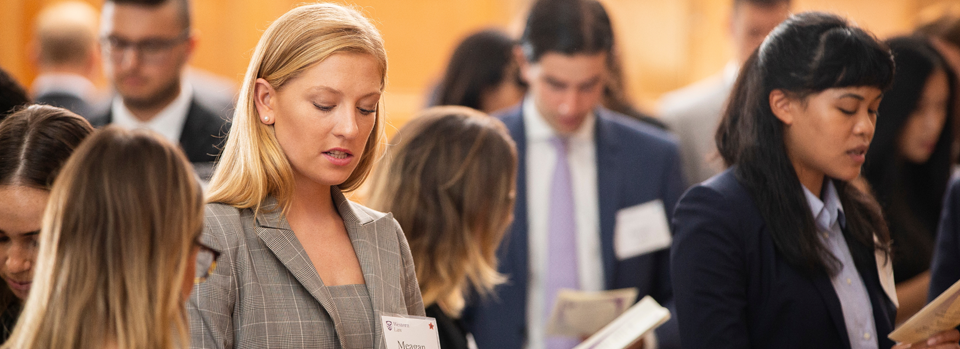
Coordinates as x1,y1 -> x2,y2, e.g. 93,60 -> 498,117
256,197 -> 345,346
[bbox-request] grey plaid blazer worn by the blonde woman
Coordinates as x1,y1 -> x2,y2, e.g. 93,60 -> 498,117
187,187 -> 424,348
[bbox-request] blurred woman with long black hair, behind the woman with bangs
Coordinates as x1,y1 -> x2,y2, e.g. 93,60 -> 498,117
863,36 -> 956,323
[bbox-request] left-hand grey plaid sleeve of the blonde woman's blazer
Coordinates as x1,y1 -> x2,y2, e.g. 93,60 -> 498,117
187,208 -> 241,349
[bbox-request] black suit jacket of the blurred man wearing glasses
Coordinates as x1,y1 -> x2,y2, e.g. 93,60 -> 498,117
90,98 -> 230,163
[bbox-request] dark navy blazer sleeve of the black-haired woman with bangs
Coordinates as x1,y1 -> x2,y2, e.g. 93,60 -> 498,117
671,186 -> 750,349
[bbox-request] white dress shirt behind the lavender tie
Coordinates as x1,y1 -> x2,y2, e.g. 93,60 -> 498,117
523,98 -> 604,349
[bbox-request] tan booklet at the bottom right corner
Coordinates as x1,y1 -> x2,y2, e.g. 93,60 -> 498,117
887,281 -> 960,343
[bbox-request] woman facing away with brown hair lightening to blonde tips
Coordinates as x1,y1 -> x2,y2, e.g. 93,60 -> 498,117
370,106 -> 517,349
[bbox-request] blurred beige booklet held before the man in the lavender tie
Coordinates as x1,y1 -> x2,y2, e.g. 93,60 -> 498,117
547,288 -> 637,338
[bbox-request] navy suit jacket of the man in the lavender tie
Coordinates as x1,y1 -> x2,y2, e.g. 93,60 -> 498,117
463,107 -> 684,349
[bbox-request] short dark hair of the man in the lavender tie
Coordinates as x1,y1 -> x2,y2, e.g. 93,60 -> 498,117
520,0 -> 613,62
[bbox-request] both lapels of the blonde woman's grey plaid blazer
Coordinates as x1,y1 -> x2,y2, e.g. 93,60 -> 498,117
256,187 -> 390,347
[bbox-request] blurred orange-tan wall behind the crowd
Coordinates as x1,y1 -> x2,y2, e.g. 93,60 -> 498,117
0,0 -> 935,127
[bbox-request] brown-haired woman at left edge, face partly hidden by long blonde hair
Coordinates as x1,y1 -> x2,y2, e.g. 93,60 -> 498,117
0,105 -> 93,341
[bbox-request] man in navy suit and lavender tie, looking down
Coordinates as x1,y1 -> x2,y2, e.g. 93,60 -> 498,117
463,0 -> 684,349
